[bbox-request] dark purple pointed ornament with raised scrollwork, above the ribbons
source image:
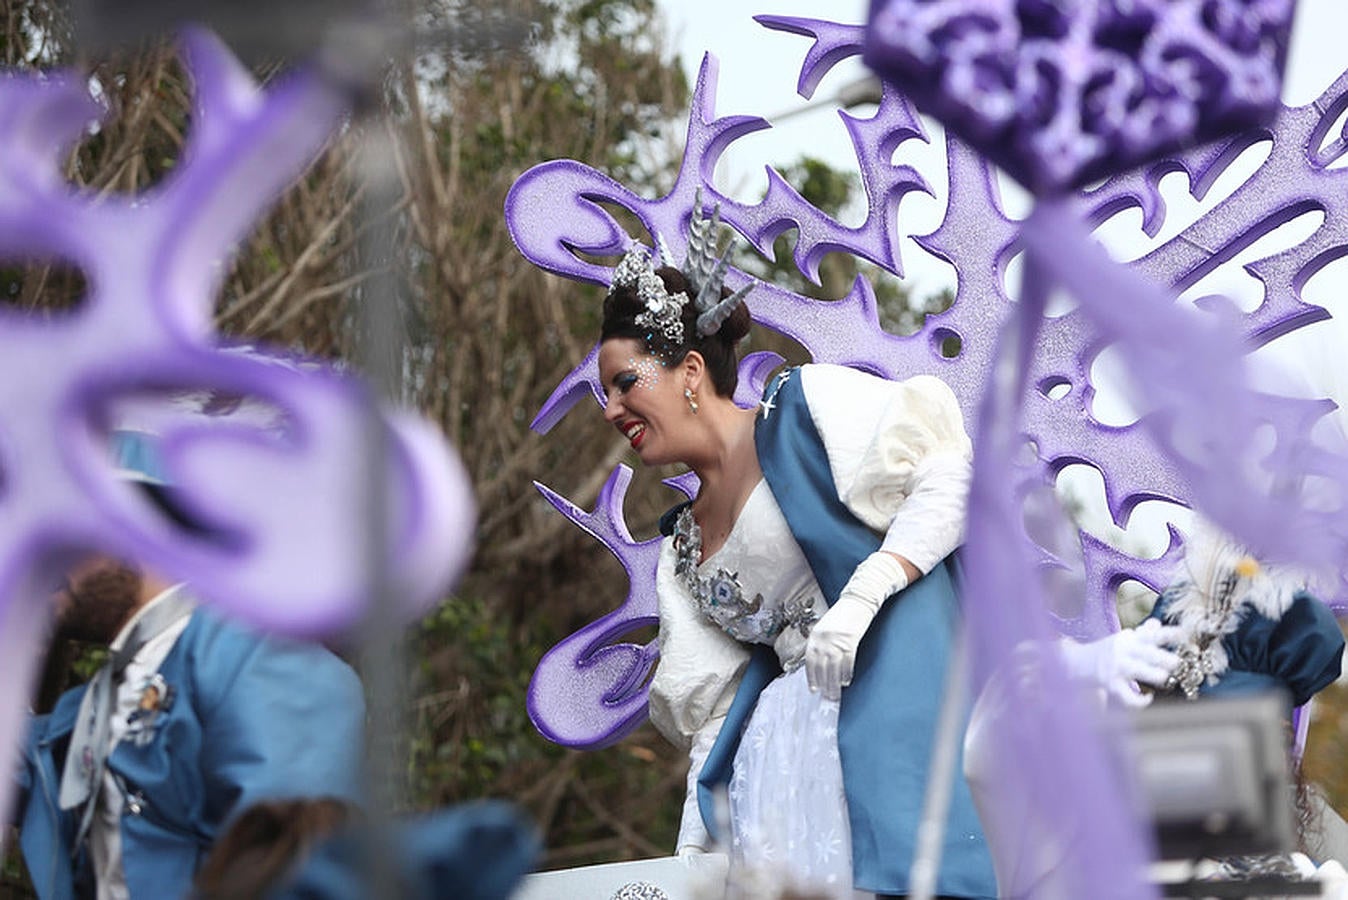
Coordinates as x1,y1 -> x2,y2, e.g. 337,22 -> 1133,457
865,0 -> 1293,195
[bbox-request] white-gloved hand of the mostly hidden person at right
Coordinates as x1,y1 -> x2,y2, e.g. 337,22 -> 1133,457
1058,618 -> 1184,706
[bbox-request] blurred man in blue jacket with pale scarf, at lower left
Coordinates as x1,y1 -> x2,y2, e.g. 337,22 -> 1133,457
18,431 -> 364,900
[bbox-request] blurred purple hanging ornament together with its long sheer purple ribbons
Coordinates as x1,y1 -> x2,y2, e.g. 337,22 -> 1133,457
865,0 -> 1305,897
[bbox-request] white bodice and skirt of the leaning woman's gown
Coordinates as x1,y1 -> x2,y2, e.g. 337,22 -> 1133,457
659,481 -> 853,897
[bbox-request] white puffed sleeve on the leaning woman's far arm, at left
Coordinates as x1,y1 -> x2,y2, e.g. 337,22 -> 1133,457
650,538 -> 749,750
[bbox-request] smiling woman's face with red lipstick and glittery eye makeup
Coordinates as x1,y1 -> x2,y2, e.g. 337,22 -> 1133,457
599,338 -> 692,465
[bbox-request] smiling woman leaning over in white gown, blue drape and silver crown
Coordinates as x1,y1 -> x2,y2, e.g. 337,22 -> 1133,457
599,212 -> 995,897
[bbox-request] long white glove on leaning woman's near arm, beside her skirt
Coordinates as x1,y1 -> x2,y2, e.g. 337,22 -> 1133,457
805,551 -> 909,701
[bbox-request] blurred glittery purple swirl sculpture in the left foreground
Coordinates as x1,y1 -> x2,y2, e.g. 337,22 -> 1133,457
0,31 -> 473,824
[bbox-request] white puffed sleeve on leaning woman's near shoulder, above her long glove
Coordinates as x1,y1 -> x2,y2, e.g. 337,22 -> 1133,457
802,365 -> 973,574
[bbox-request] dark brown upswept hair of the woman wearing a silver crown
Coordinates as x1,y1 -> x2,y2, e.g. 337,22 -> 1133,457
600,265 -> 752,397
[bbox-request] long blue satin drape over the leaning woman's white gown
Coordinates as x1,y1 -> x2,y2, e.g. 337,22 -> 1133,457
698,371 -> 996,897
